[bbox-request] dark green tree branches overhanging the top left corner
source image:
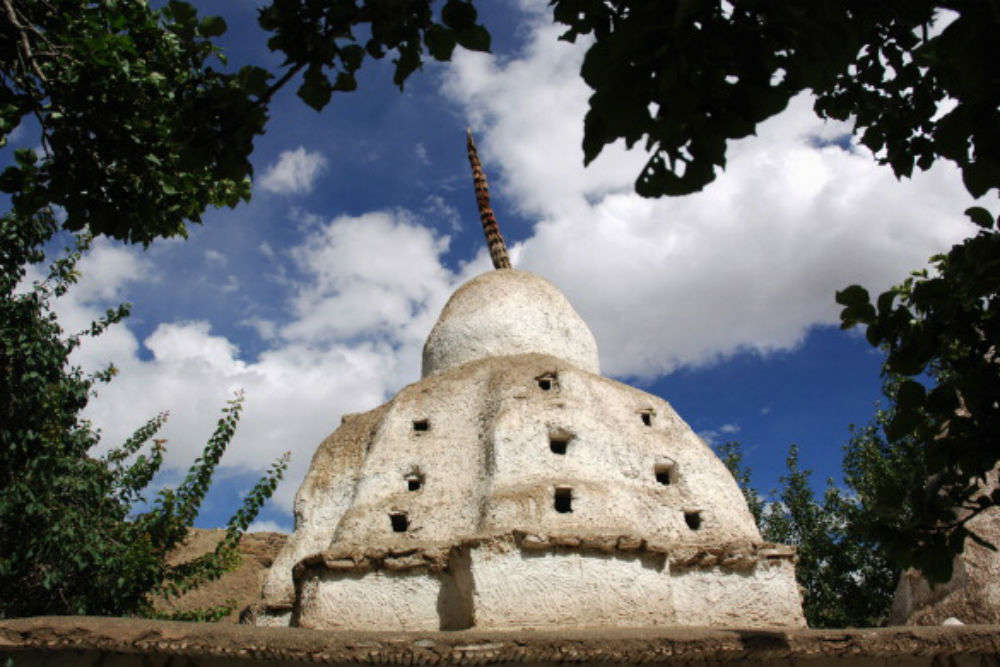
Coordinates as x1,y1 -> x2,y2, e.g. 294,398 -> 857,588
0,0 -> 489,245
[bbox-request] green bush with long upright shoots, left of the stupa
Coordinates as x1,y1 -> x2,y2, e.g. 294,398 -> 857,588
0,228 -> 287,618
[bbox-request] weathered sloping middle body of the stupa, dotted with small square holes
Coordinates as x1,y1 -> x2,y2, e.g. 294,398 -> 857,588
264,354 -> 760,628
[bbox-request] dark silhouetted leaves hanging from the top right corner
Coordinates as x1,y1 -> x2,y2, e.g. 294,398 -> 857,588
551,0 -> 1000,197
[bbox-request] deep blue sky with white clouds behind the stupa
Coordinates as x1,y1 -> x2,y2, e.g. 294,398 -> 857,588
7,0 -> 974,531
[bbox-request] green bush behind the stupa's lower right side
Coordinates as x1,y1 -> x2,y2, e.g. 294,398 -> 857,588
719,440 -> 900,628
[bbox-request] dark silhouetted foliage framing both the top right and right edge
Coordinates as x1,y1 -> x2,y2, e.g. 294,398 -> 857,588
551,0 -> 1000,580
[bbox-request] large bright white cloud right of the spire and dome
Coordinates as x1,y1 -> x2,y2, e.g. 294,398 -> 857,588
443,2 -> 973,378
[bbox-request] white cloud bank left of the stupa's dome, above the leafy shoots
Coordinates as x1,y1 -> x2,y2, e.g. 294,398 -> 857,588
70,210 -> 488,511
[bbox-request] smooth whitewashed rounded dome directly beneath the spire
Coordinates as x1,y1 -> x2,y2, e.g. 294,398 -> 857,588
423,269 -> 600,378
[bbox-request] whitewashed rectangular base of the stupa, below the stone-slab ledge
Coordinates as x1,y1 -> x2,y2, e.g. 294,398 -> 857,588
292,536 -> 804,631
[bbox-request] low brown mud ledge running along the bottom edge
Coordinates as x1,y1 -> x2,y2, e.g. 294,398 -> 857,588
0,616 -> 1000,667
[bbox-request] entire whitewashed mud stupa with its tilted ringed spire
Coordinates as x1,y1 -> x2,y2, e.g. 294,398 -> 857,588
247,136 -> 805,630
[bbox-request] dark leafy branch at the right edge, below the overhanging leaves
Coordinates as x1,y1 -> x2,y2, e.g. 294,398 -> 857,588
837,208 -> 1000,581
